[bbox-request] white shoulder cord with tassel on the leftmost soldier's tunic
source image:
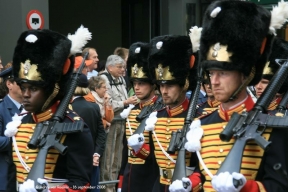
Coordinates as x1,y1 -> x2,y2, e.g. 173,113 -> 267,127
5,109 -> 69,183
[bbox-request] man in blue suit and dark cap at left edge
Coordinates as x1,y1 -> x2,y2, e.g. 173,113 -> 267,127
0,67 -> 22,192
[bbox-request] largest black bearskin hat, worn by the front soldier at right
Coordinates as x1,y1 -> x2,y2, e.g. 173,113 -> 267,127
200,0 -> 273,85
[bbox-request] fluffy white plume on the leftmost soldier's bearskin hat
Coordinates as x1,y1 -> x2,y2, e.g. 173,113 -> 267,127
67,25 -> 92,55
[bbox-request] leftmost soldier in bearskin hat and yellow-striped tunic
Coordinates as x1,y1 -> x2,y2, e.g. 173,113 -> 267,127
5,27 -> 93,192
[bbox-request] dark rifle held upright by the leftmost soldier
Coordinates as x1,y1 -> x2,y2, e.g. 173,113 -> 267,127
27,53 -> 88,191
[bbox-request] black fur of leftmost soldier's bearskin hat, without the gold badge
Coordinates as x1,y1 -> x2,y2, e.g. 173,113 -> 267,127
13,29 -> 74,95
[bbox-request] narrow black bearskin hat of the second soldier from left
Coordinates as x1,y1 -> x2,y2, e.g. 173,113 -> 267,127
127,42 -> 154,84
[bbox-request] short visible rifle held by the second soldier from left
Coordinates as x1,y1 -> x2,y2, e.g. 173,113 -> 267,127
133,95 -> 165,135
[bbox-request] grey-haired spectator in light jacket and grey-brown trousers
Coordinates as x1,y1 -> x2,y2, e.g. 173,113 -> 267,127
100,55 -> 138,192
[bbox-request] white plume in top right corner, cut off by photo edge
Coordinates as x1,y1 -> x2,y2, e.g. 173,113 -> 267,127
269,0 -> 288,35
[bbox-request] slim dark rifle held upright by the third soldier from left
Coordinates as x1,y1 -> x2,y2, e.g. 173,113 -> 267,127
167,67 -> 202,186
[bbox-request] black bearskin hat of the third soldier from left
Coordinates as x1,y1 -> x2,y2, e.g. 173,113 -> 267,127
149,35 -> 197,89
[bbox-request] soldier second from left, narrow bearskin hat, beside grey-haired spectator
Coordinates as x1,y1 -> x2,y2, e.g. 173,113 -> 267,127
120,42 -> 159,192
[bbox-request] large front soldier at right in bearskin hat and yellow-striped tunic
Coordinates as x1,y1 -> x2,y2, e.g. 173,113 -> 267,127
186,1 -> 288,192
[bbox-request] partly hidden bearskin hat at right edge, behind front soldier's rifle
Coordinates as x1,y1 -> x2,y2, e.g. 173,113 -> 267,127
262,37 -> 288,93
